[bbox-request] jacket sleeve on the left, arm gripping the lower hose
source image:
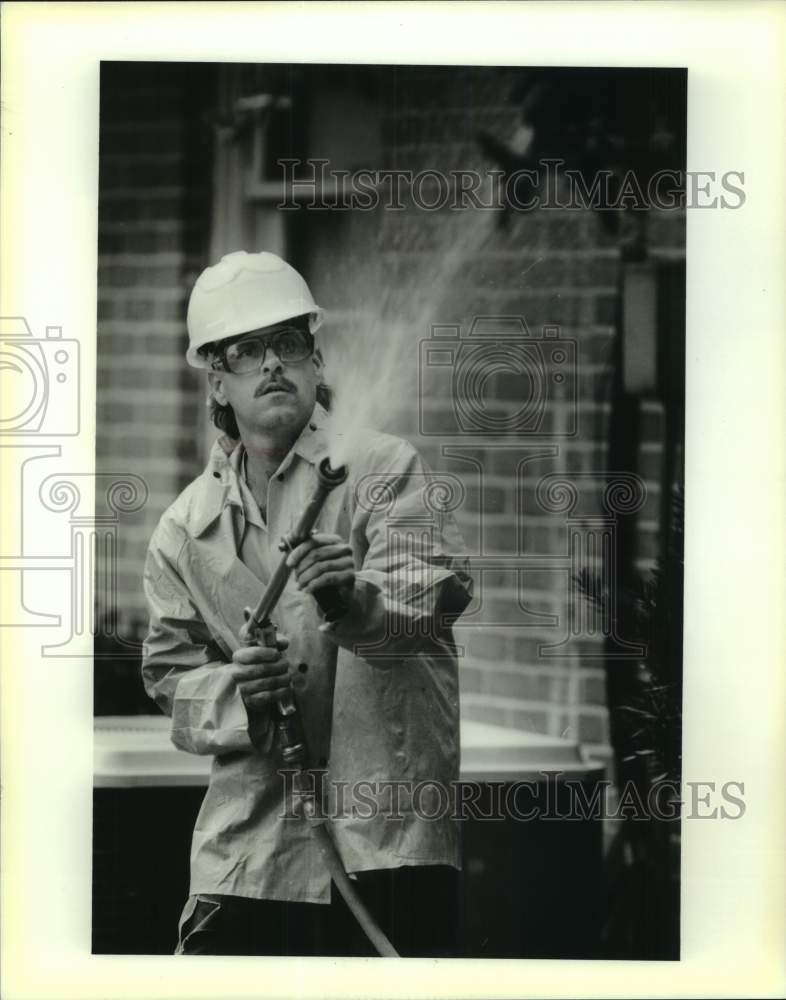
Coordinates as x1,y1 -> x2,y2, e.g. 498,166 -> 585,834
142,526 -> 272,755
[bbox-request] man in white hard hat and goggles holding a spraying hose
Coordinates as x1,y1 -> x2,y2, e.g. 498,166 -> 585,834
142,251 -> 471,955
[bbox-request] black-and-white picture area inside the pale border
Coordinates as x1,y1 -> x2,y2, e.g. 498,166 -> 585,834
93,56 -> 688,959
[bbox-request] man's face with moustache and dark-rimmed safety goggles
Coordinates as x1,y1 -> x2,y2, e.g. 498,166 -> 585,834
208,324 -> 322,436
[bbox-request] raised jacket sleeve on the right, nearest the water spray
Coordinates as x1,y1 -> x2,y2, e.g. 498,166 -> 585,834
322,438 -> 472,667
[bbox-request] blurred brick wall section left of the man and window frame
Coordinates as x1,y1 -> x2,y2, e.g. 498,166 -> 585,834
96,63 -> 213,631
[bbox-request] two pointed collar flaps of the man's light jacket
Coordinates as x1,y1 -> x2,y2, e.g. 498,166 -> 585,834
193,403 -> 329,537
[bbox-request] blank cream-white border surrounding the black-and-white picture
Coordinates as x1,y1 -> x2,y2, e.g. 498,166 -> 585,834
0,2 -> 786,1000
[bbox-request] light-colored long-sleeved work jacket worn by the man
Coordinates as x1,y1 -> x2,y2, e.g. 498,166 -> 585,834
142,406 -> 472,902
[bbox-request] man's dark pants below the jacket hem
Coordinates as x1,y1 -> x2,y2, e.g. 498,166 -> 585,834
176,866 -> 459,958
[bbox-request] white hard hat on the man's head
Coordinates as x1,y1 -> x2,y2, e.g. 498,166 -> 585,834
186,250 -> 324,368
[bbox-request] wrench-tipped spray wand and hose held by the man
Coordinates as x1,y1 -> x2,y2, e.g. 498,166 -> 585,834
240,458 -> 398,958
